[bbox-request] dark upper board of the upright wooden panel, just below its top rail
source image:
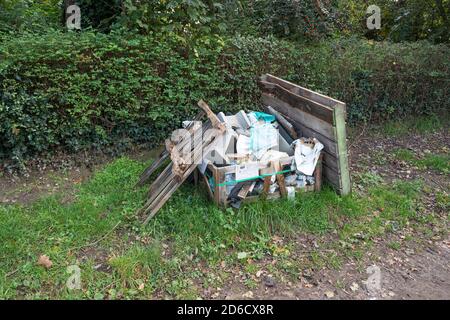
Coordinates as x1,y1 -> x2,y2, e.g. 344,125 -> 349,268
259,81 -> 334,124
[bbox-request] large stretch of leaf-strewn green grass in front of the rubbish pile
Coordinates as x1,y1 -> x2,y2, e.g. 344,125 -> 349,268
0,158 -> 442,299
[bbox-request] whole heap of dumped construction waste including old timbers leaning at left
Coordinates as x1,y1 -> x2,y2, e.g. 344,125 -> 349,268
138,101 -> 324,221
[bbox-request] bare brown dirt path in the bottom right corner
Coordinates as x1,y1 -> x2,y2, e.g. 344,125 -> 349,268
219,239 -> 450,300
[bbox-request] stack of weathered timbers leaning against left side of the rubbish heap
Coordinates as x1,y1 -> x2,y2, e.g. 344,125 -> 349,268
137,101 -> 225,224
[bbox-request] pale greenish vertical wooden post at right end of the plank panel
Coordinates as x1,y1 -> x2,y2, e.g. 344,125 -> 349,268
334,103 -> 352,195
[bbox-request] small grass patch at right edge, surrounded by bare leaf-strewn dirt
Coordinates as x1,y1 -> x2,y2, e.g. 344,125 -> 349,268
394,148 -> 450,174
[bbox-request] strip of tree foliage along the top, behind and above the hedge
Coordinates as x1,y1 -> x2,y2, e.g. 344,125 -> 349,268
0,0 -> 450,46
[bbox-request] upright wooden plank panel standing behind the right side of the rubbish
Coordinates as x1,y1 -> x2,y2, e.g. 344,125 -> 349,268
259,74 -> 351,195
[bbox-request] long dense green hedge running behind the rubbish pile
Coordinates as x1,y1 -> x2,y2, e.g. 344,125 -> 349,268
0,31 -> 450,168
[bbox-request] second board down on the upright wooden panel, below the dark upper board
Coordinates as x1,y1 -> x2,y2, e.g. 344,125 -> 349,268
262,93 -> 335,140
